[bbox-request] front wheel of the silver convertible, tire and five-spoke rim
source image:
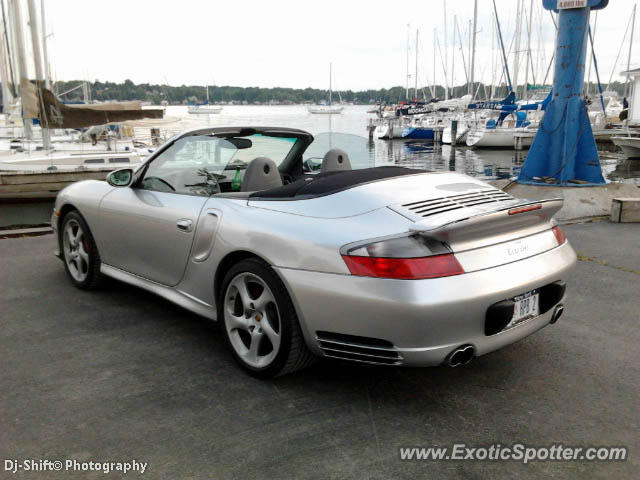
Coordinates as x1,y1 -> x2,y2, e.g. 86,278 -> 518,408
58,211 -> 102,290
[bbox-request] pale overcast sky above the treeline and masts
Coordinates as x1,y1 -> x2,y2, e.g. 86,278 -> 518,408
41,0 -> 640,90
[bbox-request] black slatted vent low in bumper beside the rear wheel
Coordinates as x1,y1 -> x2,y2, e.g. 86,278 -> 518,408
316,331 -> 402,365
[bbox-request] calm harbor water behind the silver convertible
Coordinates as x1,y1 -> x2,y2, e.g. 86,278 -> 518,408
0,105 -> 640,227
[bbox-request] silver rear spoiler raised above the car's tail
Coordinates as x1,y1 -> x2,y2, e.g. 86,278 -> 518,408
409,198 -> 564,240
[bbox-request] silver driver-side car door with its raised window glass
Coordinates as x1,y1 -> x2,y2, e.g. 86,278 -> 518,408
97,137 -> 229,286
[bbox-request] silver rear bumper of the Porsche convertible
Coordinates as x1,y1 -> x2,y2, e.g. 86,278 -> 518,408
276,242 -> 576,366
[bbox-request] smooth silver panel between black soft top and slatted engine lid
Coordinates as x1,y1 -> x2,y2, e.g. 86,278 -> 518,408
248,172 -> 497,218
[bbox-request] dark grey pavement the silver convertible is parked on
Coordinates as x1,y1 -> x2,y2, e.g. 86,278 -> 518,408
0,223 -> 640,479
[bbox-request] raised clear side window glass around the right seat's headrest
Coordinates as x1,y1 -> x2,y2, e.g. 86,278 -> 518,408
302,132 -> 375,173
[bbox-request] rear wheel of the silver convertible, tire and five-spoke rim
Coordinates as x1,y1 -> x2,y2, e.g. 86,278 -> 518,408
218,258 -> 316,378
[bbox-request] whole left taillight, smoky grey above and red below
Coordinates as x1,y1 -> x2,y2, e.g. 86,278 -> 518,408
341,235 -> 464,280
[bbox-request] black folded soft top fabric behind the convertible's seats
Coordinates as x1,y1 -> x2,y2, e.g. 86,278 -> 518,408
249,166 -> 425,200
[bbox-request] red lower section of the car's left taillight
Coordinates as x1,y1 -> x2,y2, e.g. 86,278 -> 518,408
342,253 -> 464,280
